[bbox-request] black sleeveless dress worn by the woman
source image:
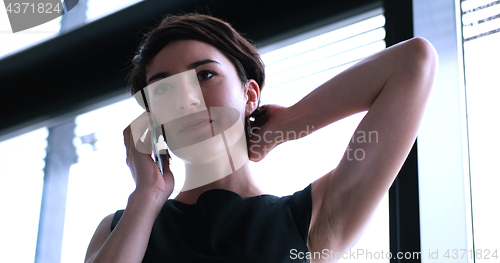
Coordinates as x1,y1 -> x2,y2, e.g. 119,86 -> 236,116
111,184 -> 312,263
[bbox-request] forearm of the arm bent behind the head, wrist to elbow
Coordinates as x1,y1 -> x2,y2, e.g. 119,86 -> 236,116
280,38 -> 428,139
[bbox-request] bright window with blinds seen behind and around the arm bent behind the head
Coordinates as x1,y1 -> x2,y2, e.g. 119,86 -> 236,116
252,9 -> 390,262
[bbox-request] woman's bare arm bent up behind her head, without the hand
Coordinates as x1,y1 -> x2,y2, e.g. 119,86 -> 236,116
278,38 -> 438,260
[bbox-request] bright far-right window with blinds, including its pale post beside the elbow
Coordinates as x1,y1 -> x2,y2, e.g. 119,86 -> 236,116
413,0 -> 500,262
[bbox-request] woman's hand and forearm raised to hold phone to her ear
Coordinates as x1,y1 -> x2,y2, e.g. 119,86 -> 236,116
85,127 -> 174,263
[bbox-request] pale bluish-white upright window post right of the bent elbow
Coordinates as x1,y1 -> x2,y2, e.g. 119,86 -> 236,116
413,0 -> 473,262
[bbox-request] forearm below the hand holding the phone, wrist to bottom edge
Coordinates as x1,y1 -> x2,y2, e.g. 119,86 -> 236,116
86,192 -> 161,263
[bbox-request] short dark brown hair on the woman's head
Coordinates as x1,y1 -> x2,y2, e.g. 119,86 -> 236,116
129,13 -> 265,98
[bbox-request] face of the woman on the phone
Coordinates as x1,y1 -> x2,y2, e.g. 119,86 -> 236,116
146,40 -> 258,161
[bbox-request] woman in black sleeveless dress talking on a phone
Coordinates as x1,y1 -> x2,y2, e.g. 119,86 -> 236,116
86,14 -> 437,262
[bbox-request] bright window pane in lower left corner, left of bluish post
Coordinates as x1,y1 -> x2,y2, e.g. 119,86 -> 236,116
0,128 -> 48,262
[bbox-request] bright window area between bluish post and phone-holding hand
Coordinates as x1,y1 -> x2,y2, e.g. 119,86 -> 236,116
61,99 -> 139,263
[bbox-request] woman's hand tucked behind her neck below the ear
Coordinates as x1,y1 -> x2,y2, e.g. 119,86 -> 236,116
248,104 -> 287,162
